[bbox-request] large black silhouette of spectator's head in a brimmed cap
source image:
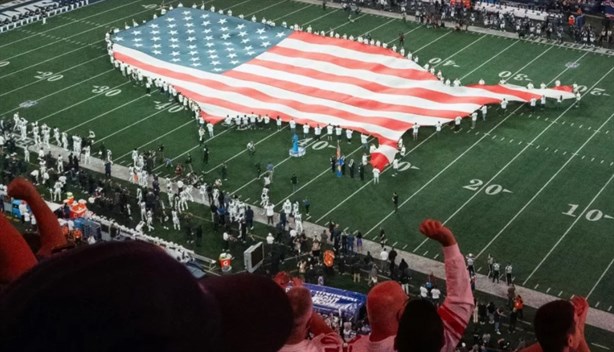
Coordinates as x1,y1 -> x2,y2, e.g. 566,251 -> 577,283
0,241 -> 292,352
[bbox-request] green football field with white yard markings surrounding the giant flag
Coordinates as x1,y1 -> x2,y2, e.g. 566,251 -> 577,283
0,0 -> 614,311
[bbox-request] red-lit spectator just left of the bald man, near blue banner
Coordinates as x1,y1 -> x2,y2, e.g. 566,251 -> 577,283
279,287 -> 343,352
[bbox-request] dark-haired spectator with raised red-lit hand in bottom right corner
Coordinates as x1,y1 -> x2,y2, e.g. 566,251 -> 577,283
522,297 -> 590,352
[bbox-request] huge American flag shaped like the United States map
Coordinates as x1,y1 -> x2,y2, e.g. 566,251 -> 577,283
112,8 -> 573,170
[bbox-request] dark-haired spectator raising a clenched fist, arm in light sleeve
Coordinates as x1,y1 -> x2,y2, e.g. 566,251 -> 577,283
394,219 -> 474,352
